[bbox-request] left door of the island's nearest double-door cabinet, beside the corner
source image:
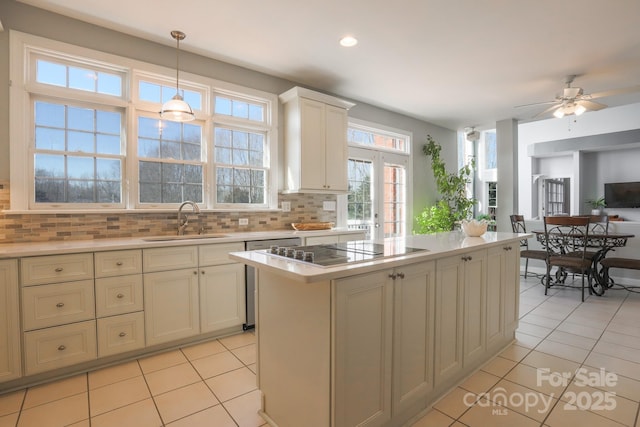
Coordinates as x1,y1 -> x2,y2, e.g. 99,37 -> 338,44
333,270 -> 394,426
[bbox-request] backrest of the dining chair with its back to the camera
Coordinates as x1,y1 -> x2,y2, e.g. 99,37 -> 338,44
544,216 -> 590,259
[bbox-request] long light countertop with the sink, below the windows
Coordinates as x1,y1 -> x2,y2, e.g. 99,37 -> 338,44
0,228 -> 362,259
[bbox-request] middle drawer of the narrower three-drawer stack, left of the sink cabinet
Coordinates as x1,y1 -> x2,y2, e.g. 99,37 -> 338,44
96,274 -> 143,317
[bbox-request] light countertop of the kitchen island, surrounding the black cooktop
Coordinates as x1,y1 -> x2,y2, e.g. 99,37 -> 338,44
229,231 -> 532,283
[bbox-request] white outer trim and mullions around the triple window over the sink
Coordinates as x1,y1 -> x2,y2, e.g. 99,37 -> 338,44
5,30 -> 279,214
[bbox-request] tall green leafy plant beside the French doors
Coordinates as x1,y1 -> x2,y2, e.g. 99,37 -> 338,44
415,135 -> 476,234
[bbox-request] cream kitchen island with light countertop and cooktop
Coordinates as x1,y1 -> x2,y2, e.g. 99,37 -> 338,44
230,232 -> 529,427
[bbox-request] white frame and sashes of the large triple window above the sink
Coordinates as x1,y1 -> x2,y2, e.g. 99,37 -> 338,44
8,30 -> 278,213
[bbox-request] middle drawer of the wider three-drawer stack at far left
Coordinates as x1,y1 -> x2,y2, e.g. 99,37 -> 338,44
22,280 -> 95,331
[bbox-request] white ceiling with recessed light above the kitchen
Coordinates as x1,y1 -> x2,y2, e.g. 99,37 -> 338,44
20,0 -> 640,129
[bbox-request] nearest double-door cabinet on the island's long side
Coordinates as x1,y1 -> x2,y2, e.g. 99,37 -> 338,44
334,262 -> 435,426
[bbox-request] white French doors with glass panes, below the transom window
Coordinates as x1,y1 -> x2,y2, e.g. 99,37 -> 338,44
346,147 -> 409,239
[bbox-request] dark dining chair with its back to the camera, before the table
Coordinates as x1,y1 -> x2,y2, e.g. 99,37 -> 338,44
544,216 -> 592,301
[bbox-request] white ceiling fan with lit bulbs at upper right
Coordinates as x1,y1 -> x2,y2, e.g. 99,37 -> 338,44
516,75 -> 640,118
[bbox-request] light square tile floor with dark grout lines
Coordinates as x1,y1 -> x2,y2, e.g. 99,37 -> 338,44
0,278 -> 640,427
